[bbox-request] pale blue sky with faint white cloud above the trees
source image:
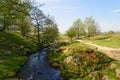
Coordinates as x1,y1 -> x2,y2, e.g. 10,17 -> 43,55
36,0 -> 120,33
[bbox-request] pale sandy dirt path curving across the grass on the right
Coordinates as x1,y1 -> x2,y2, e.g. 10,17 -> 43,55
77,40 -> 120,61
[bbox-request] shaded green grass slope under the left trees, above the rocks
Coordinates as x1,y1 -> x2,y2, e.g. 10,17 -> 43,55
0,32 -> 36,52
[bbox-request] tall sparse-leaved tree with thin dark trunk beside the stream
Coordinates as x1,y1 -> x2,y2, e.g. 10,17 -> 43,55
30,6 -> 46,49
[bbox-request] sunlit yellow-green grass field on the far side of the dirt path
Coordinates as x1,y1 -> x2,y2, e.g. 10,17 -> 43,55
84,33 -> 120,48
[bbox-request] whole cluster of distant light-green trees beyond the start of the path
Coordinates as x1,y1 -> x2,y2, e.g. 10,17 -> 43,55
66,17 -> 100,40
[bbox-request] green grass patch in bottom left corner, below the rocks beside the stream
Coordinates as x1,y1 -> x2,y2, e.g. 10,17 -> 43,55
0,56 -> 27,78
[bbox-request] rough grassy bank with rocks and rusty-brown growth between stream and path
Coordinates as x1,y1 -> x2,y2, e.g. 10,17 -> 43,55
48,42 -> 120,80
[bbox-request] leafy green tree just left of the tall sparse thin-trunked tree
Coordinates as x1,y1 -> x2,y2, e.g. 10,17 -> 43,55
14,0 -> 32,37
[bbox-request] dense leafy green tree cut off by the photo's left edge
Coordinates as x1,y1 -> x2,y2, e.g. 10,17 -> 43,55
0,0 -> 13,31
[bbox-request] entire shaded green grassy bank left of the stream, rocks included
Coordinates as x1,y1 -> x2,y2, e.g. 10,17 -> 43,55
0,32 -> 36,80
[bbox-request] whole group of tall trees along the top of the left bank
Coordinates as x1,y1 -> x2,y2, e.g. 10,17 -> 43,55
0,0 -> 59,48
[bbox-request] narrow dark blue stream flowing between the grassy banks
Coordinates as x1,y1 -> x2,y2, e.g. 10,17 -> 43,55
18,48 -> 61,80
